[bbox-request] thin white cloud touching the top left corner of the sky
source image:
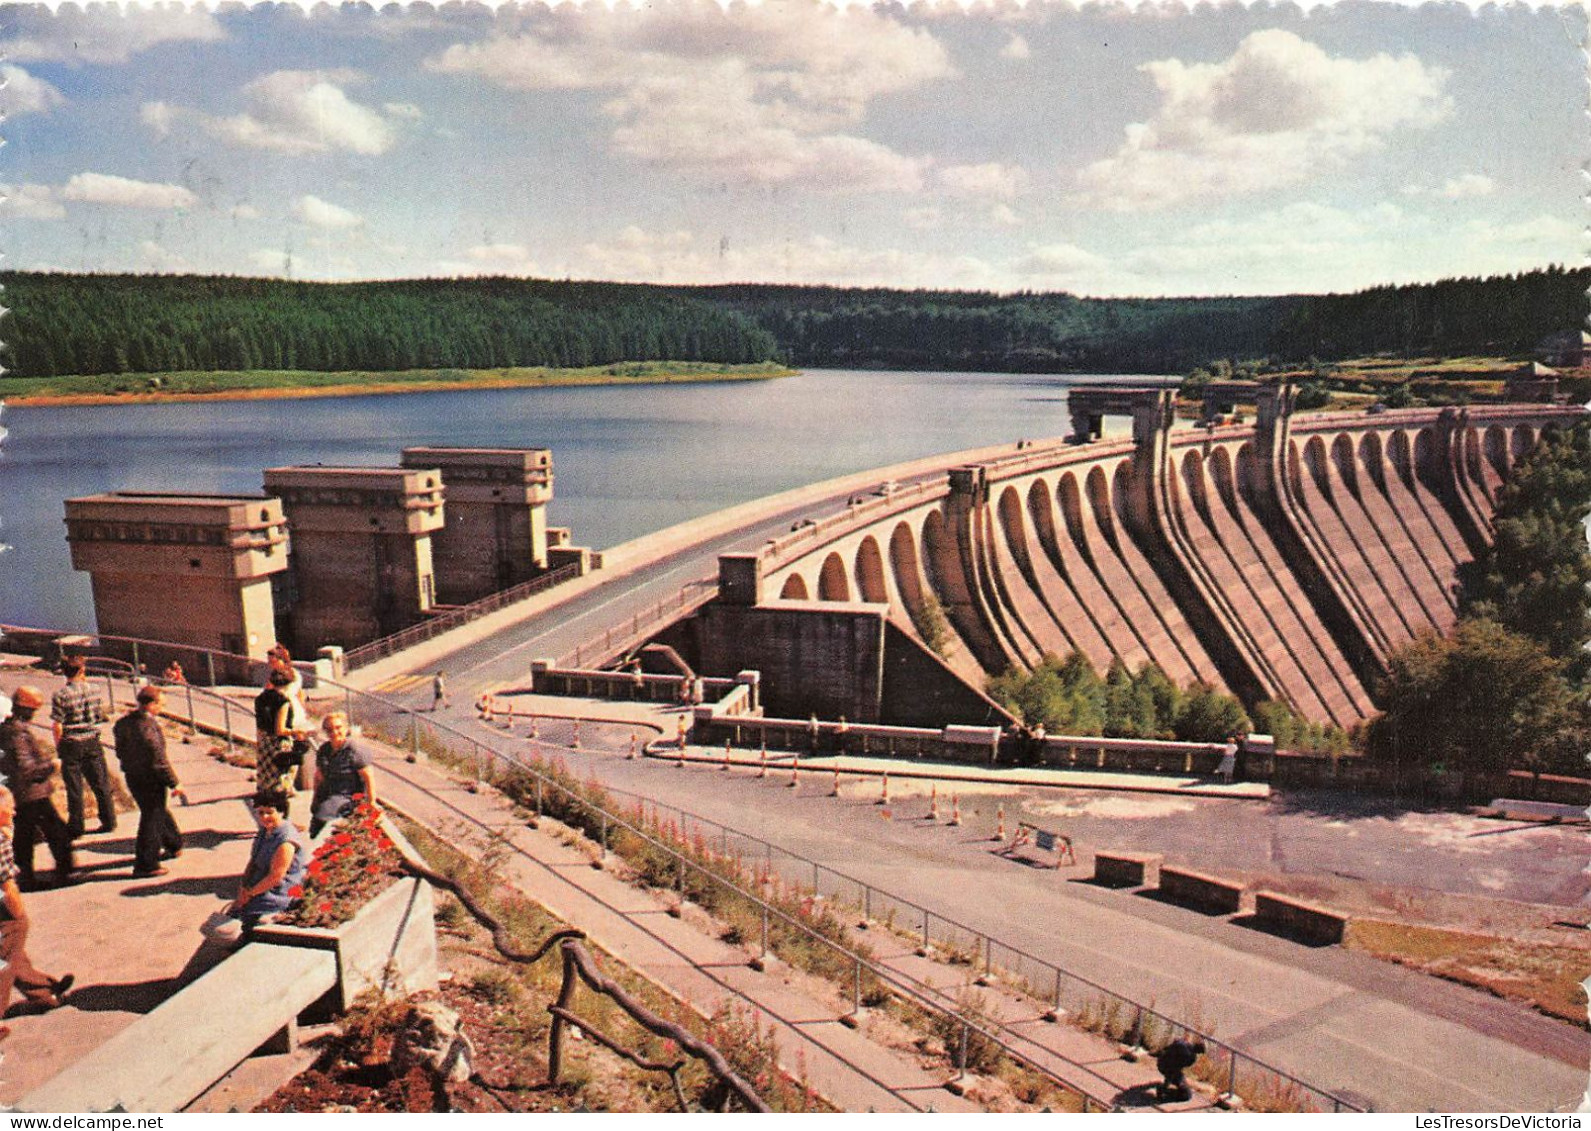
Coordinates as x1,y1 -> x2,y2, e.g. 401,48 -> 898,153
0,5 -> 226,64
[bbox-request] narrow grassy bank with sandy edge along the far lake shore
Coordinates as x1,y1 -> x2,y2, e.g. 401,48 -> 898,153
0,361 -> 796,406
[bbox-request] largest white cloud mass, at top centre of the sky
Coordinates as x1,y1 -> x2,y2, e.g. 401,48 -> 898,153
425,5 -> 953,191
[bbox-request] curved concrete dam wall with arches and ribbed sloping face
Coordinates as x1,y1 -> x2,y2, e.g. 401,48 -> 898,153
708,394 -> 1583,725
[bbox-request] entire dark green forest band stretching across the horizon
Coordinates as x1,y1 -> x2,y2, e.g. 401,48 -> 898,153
0,266 -> 1591,377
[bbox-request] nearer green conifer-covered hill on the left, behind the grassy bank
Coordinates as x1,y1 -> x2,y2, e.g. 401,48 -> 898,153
0,272 -> 778,377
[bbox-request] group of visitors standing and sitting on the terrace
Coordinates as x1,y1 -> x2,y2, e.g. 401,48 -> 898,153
0,646 -> 375,1040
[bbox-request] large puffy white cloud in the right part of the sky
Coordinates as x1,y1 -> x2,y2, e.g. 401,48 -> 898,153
1077,29 -> 1453,210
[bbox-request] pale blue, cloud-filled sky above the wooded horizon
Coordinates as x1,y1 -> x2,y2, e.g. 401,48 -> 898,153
0,0 -> 1591,296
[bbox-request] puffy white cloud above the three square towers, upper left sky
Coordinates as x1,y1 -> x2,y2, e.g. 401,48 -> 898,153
140,70 -> 400,156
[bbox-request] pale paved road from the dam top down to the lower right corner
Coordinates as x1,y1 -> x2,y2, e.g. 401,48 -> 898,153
361,454 -> 1591,1110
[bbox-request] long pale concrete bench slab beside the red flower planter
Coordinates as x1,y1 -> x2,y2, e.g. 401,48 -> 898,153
18,943 -> 337,1112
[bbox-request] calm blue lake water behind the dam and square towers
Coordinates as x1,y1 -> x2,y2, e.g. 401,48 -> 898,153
0,371 -> 1158,630
